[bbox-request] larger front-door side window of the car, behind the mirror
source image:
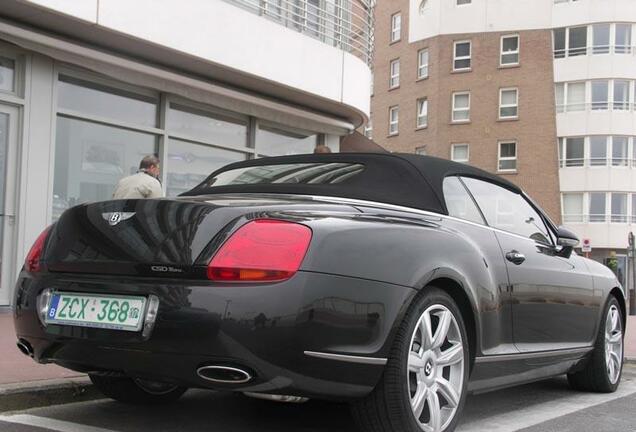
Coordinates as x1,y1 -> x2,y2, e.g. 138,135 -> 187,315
463,178 -> 552,244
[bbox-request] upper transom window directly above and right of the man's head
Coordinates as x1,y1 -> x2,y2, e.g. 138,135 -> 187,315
167,106 -> 247,147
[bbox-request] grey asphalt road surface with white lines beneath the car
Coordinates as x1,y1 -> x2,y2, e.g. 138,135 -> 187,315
0,366 -> 636,432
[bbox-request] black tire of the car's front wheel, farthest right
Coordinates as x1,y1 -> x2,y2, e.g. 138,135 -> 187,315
568,296 -> 625,393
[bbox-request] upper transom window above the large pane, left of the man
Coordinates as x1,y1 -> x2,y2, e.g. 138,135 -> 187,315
58,77 -> 157,127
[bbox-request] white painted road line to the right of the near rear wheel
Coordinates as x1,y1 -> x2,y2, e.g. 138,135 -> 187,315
457,381 -> 636,432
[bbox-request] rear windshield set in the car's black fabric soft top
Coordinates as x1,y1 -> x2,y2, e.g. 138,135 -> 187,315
205,163 -> 364,187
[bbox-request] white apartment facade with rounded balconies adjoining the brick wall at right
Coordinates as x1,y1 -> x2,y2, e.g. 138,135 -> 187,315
408,0 -> 636,282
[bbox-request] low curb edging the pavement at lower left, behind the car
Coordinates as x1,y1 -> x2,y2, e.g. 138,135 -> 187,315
0,377 -> 104,413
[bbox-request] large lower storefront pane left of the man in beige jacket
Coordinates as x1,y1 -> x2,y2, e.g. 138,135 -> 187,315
53,117 -> 158,221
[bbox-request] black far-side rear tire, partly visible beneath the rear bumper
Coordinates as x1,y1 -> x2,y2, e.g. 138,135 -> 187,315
89,374 -> 187,405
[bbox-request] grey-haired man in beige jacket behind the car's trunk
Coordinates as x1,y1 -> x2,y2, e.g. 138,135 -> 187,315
113,156 -> 163,199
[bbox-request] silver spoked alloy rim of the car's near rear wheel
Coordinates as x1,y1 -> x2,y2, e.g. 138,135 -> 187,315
408,304 -> 465,432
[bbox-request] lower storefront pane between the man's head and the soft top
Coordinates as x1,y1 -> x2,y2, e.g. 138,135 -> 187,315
166,139 -> 245,196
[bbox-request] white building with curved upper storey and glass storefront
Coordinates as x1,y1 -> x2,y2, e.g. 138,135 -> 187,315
0,0 -> 373,306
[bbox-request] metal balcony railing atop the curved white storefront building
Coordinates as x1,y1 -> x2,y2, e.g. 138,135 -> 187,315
225,0 -> 375,66
